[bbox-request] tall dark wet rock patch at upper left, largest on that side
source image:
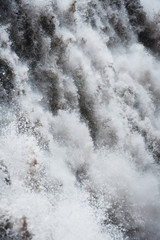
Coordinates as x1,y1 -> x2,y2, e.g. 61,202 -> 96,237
10,3 -> 42,61
